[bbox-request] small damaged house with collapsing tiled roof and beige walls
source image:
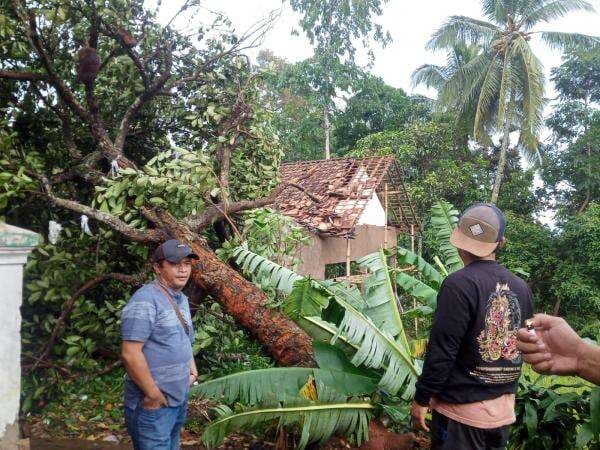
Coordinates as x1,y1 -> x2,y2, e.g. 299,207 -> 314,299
275,156 -> 419,279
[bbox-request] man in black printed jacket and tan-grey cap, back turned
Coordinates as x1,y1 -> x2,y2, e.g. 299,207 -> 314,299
411,203 -> 533,450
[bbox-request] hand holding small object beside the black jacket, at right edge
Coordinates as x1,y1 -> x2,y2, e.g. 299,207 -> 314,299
517,314 -> 584,375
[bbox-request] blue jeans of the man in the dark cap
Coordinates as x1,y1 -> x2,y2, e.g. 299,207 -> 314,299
125,402 -> 187,450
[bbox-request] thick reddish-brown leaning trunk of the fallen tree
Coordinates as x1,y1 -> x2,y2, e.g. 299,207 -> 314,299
157,212 -> 315,367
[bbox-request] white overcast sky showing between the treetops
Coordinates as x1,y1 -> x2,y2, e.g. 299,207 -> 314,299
161,0 -> 600,96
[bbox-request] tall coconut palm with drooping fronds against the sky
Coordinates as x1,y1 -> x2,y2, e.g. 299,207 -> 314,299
415,0 -> 600,203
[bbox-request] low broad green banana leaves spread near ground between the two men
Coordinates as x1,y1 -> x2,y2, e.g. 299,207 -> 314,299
190,342 -> 377,449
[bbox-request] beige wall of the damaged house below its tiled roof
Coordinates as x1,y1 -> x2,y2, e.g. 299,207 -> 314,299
298,225 -> 398,279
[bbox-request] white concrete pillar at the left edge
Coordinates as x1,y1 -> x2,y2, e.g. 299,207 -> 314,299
0,222 -> 39,450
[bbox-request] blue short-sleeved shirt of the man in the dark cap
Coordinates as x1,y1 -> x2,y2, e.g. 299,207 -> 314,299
121,281 -> 194,409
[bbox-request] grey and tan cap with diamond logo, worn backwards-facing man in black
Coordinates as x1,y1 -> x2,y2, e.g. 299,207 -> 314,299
450,203 -> 506,257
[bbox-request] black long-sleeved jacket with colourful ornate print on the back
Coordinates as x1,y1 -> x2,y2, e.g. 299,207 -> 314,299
415,260 -> 533,406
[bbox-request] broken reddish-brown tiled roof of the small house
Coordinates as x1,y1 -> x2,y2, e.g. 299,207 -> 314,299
275,156 -> 418,237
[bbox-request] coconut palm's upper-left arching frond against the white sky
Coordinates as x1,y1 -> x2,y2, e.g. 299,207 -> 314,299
426,16 -> 501,50
